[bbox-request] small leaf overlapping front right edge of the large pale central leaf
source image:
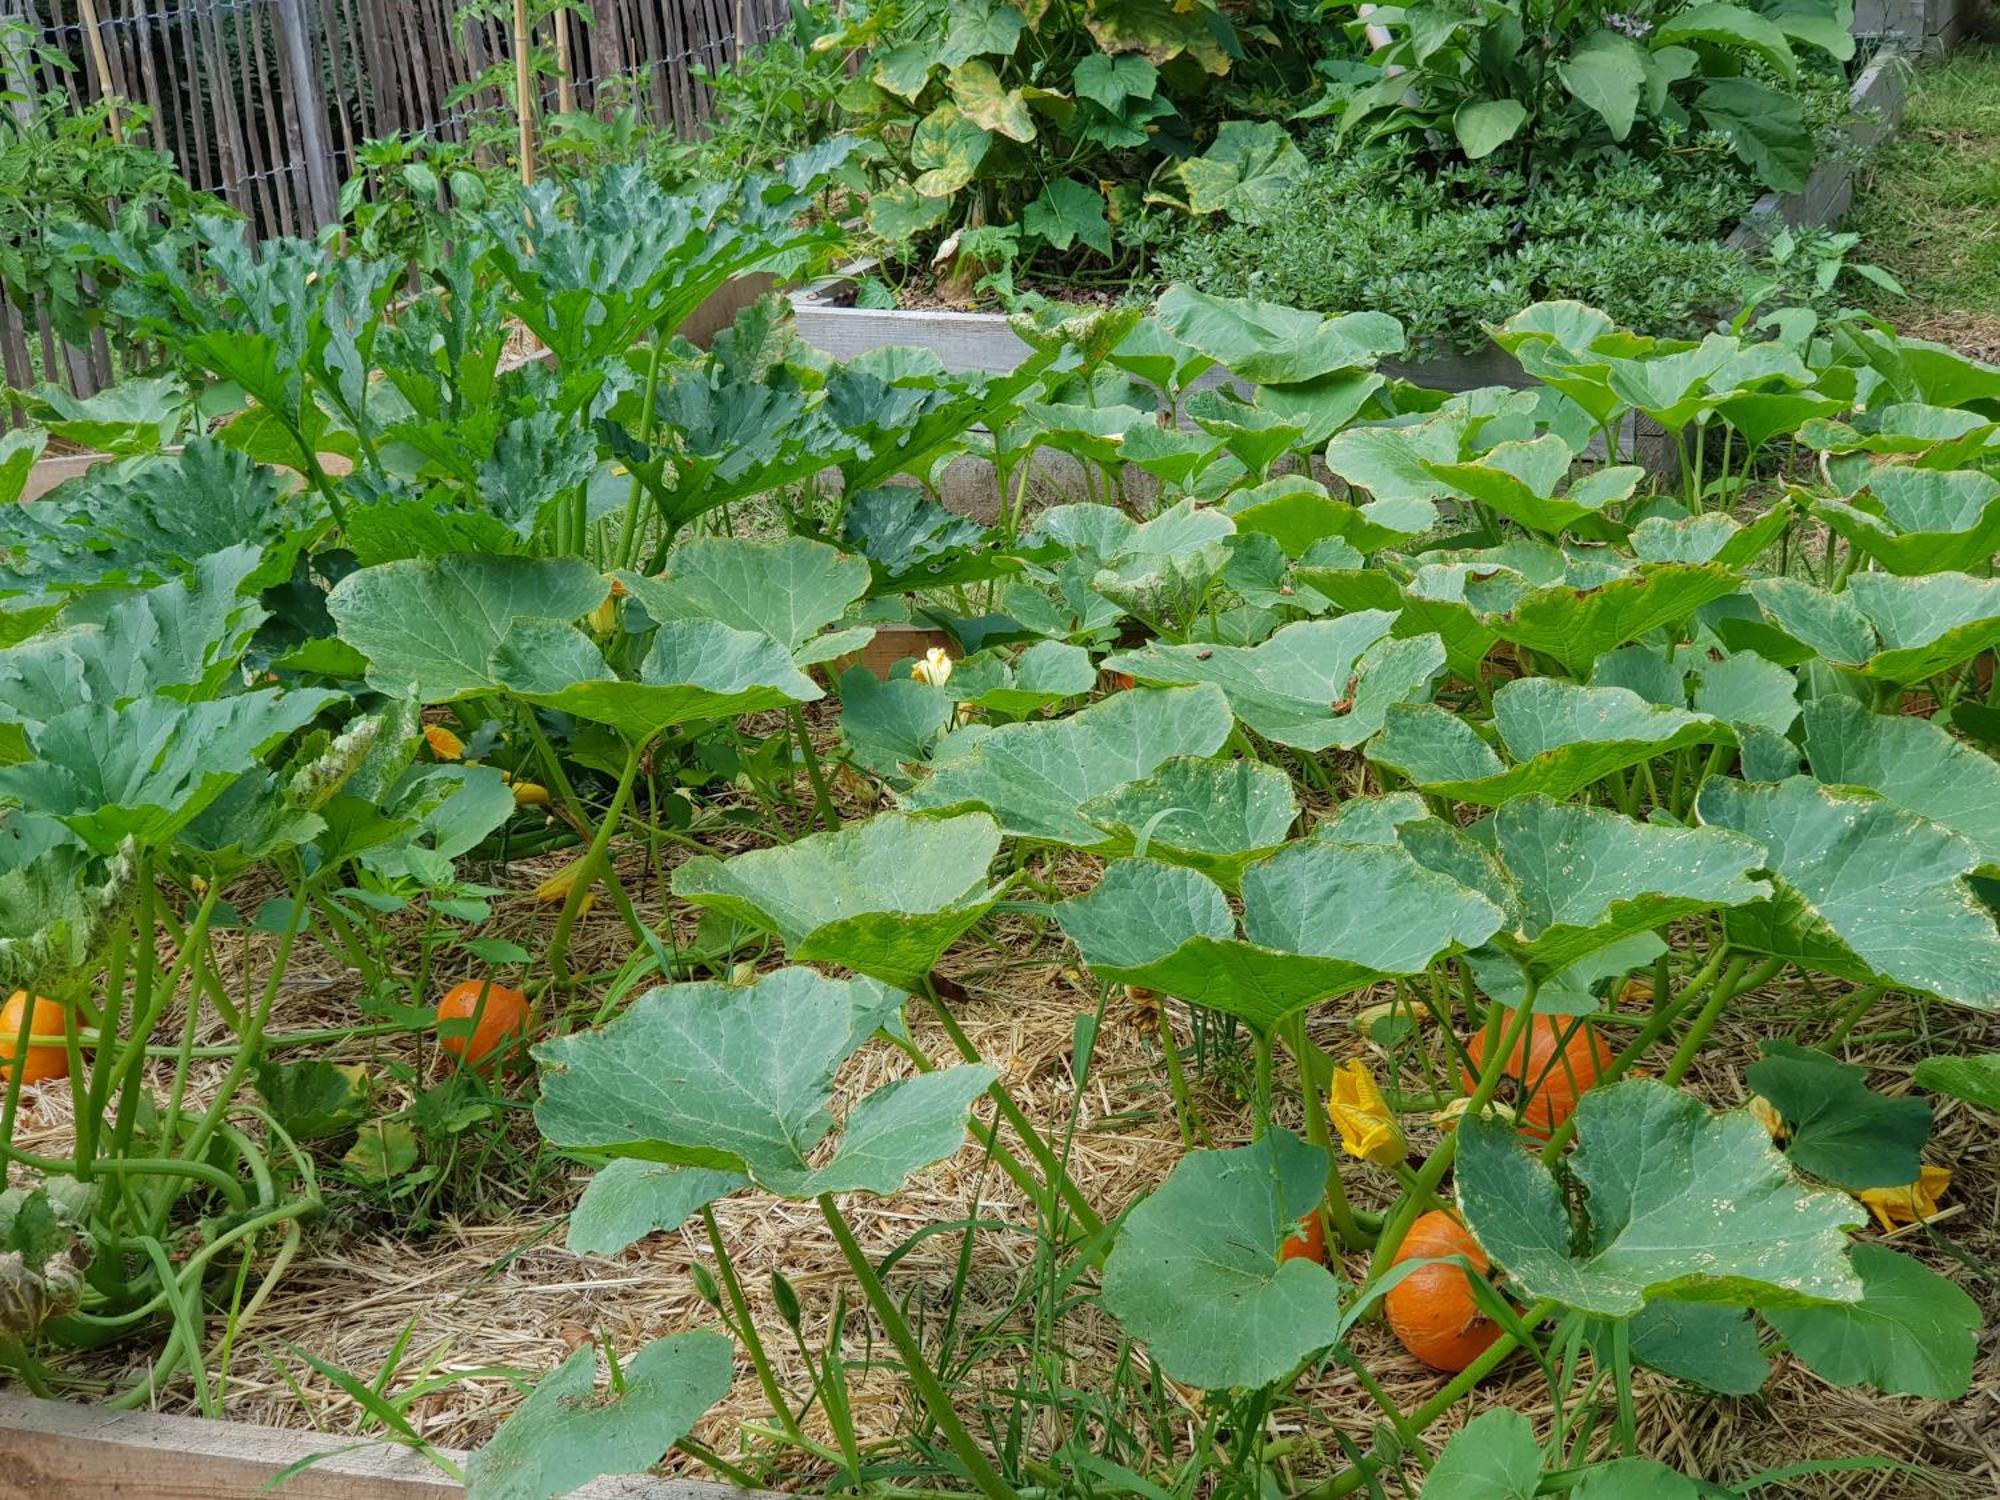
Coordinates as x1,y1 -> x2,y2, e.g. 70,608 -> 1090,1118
1078,756 -> 1298,890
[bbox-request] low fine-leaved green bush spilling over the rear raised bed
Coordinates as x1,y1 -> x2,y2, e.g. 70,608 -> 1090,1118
1156,136 -> 1856,350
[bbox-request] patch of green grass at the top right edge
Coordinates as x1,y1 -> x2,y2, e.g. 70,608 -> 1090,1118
1852,44 -> 2000,322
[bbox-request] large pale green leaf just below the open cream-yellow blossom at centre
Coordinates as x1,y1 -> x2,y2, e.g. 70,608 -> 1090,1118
902,684 -> 1232,848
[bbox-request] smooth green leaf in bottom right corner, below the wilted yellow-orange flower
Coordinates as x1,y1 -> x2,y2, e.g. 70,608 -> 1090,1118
1764,1244 -> 1980,1400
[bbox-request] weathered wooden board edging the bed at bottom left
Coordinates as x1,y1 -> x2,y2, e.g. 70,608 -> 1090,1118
0,1390 -> 764,1500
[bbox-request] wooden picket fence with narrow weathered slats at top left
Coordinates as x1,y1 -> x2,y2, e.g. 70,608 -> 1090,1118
0,0 -> 788,402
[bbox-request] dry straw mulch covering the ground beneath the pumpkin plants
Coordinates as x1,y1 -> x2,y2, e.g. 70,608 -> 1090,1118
3,748 -> 2000,1500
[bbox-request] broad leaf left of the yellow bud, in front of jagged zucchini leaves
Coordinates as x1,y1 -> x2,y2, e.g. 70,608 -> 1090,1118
326,552 -> 610,702
